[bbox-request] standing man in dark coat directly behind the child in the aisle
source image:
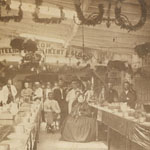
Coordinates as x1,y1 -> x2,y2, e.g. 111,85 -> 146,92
53,80 -> 68,124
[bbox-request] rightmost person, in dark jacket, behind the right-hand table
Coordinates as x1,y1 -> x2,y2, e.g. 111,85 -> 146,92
120,81 -> 137,108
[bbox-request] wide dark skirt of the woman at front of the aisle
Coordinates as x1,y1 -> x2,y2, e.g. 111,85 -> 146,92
61,115 -> 96,142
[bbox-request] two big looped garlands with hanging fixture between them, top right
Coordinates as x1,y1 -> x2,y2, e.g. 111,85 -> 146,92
74,0 -> 147,31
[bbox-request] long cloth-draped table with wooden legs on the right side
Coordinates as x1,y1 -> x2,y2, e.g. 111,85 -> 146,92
89,104 -> 150,150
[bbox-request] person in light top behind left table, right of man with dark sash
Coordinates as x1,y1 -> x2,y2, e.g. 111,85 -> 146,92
21,82 -> 33,103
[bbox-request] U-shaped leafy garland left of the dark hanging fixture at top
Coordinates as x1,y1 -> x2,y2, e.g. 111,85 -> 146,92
75,3 -> 104,26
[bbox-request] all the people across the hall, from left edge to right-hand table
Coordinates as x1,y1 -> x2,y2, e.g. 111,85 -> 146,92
0,79 -> 137,142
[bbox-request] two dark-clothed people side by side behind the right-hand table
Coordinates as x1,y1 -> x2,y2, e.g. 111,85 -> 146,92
99,81 -> 137,109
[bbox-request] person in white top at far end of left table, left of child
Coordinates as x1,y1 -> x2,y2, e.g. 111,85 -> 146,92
32,82 -> 43,101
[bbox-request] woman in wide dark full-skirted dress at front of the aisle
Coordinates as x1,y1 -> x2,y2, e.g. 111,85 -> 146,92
61,94 -> 96,142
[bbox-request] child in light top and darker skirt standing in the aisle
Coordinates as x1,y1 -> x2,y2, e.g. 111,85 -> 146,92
44,92 -> 60,132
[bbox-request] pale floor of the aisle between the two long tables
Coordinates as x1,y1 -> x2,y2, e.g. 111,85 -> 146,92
38,131 -> 107,150
